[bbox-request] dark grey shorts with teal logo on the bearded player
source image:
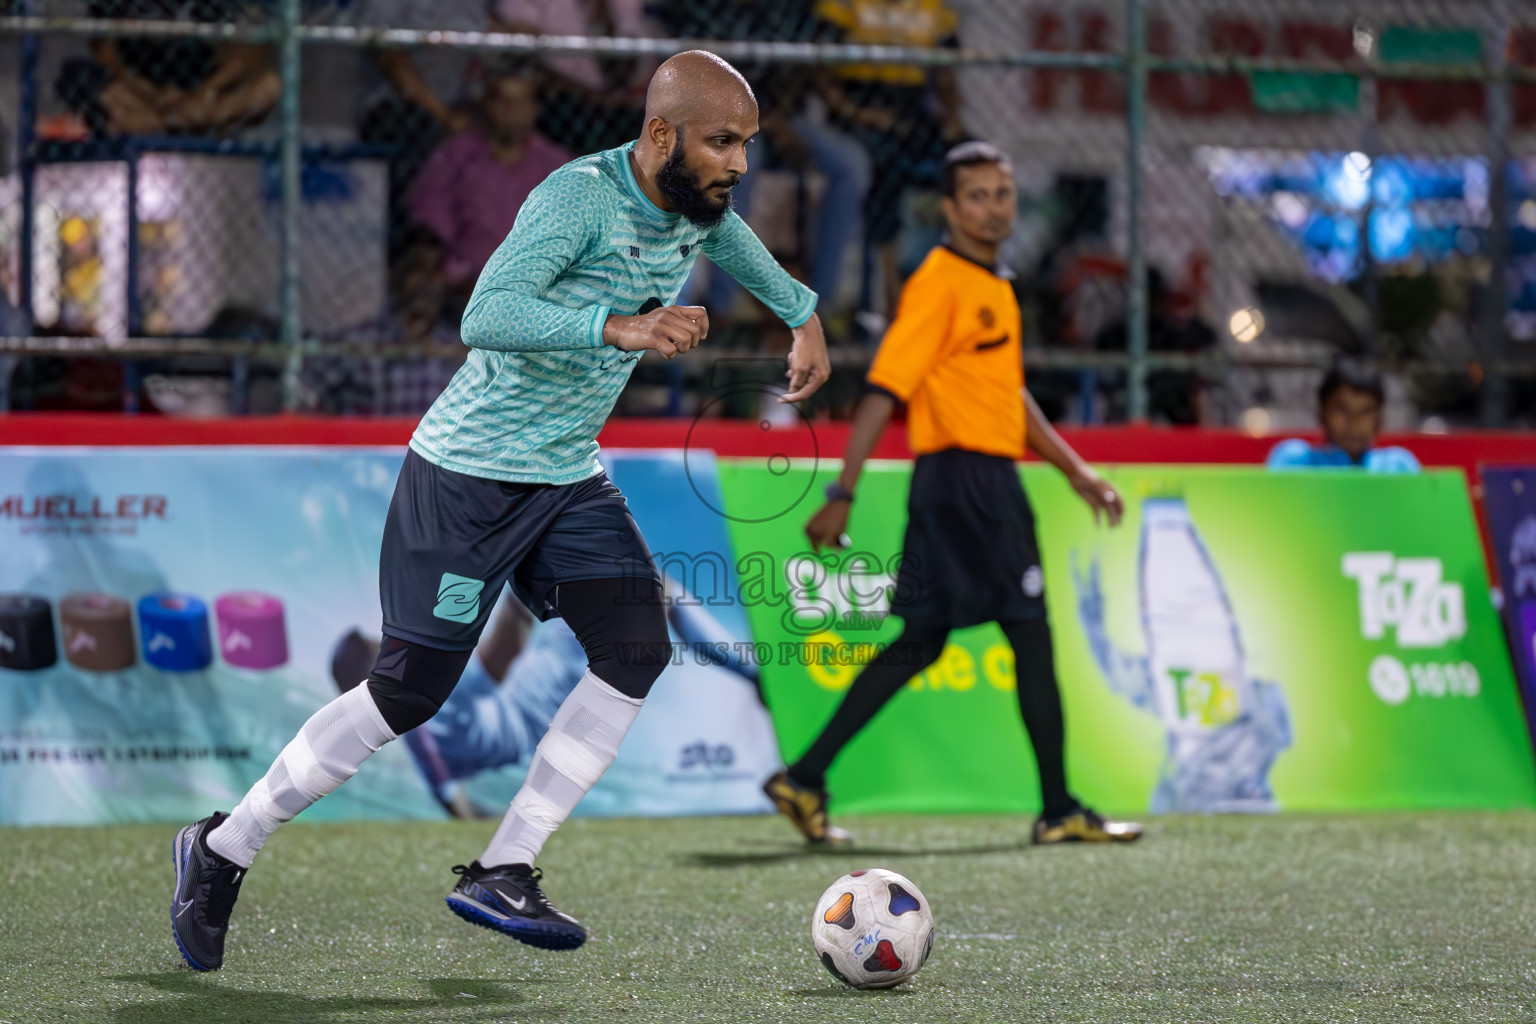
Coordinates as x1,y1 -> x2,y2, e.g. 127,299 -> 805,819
379,451 -> 660,651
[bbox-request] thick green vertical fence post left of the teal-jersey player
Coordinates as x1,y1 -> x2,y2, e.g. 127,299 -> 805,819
278,0 -> 304,413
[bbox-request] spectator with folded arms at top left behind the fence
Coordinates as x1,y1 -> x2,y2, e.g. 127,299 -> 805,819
55,0 -> 283,135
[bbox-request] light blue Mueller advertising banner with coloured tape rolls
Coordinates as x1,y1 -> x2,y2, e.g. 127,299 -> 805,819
0,448 -> 777,824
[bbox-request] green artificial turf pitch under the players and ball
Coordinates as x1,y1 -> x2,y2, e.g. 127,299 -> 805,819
0,814 -> 1536,1024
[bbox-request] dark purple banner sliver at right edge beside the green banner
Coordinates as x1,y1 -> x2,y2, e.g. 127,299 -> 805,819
1482,465 -> 1536,746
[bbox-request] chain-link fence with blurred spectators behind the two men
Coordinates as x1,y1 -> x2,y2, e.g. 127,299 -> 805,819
0,0 -> 1536,431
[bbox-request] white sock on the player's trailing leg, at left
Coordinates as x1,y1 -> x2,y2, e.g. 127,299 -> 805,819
207,683 -> 395,867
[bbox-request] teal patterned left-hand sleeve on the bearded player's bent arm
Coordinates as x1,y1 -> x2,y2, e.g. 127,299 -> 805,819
461,173 -> 610,352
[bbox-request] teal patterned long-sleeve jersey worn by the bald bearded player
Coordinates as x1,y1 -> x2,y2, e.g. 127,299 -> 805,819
410,143 -> 816,484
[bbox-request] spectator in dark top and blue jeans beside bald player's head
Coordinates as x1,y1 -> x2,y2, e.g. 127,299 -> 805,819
654,0 -> 869,324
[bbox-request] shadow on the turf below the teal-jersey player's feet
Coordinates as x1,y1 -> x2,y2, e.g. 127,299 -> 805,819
111,970 -> 565,1024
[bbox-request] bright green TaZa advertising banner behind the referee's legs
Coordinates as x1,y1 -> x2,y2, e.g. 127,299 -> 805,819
720,462 -> 1536,814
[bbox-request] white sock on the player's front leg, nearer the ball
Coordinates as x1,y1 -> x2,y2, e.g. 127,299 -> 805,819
481,671 -> 644,867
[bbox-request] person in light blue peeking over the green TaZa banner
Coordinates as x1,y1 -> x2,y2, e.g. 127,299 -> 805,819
1266,359 -> 1419,473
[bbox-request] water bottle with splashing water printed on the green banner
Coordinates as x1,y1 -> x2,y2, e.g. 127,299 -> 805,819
1074,496 -> 1290,812
